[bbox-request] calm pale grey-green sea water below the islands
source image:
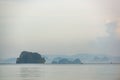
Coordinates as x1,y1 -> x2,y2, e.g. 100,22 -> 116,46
0,64 -> 120,80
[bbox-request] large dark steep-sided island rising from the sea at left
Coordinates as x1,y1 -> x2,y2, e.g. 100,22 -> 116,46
16,51 -> 46,64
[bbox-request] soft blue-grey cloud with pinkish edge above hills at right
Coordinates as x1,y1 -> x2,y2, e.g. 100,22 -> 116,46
93,21 -> 120,55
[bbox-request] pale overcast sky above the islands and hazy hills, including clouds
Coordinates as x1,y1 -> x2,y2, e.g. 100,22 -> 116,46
0,0 -> 120,59
